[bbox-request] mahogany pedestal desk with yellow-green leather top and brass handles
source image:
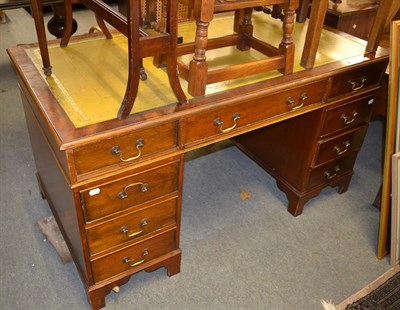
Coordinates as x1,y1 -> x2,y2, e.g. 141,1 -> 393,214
8,17 -> 388,309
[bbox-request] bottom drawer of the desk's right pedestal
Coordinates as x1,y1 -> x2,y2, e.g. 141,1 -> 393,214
307,152 -> 357,189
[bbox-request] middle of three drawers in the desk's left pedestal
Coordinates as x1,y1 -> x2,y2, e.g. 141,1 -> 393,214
86,198 -> 178,255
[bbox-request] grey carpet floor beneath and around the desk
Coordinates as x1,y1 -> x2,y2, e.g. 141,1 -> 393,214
0,9 -> 390,310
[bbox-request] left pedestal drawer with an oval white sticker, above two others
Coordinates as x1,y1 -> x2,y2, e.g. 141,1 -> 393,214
81,162 -> 179,221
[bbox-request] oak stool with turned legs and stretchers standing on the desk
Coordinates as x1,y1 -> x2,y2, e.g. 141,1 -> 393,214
155,0 -> 298,96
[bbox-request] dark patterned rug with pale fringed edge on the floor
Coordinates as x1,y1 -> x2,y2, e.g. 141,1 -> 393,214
321,265 -> 400,310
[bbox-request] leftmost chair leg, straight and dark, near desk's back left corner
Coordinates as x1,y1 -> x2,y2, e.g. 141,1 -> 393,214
31,0 -> 51,76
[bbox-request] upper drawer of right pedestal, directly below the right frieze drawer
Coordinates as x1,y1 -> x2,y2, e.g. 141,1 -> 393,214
321,96 -> 374,136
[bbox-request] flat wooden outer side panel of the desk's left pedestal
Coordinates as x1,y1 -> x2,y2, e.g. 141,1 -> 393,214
21,87 -> 88,282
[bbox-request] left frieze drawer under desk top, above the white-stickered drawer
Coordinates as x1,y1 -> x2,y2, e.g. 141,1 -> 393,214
74,122 -> 177,175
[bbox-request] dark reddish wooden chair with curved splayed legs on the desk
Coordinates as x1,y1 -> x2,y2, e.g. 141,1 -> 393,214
31,0 -> 187,119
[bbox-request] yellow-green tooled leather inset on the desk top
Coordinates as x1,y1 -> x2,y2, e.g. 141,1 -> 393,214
28,13 -> 376,128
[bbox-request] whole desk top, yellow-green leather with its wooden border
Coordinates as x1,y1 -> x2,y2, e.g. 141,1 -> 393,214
8,12 -> 387,147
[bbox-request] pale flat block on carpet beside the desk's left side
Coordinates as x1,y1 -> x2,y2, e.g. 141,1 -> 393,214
38,216 -> 72,264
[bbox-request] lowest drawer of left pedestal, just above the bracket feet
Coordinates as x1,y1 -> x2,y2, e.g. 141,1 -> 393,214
92,229 -> 177,282
